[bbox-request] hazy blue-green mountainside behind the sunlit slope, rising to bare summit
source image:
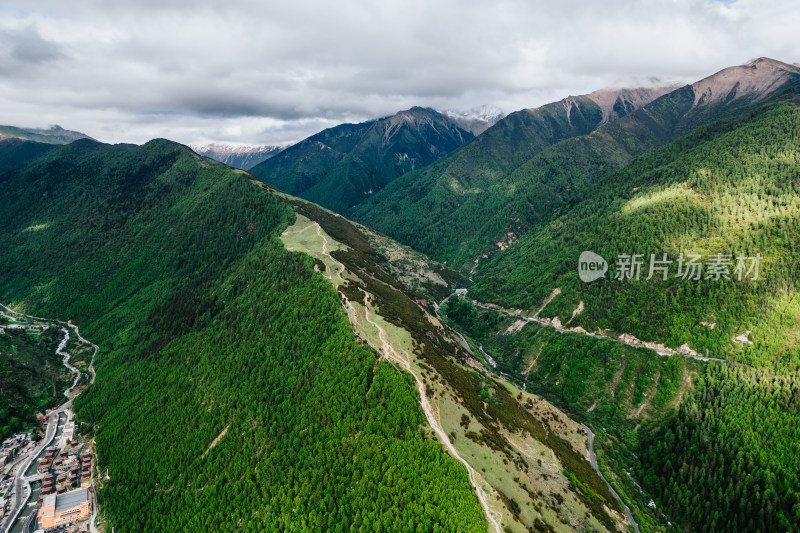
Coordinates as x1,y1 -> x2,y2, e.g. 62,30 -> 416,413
351,59 -> 800,272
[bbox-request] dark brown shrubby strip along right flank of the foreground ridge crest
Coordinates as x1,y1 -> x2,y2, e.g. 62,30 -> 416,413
292,200 -> 632,531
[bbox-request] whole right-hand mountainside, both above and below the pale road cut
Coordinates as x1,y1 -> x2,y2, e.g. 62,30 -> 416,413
462,94 -> 800,532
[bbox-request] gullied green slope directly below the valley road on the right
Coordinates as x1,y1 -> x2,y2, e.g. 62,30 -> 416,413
442,298 -> 692,532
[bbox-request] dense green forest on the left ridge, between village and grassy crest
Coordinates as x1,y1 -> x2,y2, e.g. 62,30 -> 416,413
0,140 -> 486,532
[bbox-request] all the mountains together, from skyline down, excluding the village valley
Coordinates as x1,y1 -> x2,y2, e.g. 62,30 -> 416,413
0,58 -> 800,533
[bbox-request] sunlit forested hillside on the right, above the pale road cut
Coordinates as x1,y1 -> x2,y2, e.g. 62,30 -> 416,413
473,100 -> 800,370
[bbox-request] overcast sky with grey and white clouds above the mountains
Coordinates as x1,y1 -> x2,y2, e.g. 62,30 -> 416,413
0,0 -> 800,144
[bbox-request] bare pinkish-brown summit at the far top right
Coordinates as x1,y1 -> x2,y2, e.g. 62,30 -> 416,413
692,57 -> 800,106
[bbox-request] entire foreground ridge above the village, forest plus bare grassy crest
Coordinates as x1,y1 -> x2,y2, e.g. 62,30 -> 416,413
0,140 -> 624,533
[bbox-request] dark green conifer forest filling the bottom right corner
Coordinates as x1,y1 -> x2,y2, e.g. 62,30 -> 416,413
640,363 -> 800,532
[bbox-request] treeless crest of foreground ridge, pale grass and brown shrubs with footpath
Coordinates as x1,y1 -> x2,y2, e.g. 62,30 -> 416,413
268,193 -> 625,532
